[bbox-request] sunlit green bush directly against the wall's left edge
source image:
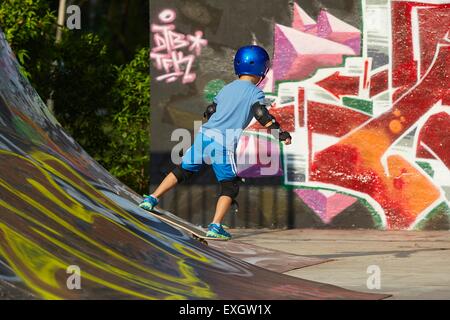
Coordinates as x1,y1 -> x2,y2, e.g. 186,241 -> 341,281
105,48 -> 150,192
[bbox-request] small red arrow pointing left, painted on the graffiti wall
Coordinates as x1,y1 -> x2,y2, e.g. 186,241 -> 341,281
316,71 -> 359,99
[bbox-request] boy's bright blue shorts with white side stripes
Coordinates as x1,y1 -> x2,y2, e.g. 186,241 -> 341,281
181,132 -> 237,181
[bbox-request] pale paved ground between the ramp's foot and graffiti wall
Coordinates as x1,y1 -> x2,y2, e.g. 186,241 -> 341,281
232,229 -> 450,299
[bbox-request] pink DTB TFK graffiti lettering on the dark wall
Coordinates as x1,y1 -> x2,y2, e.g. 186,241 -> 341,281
150,9 -> 208,84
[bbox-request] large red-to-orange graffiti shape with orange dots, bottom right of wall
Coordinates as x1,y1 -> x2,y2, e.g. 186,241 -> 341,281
310,38 -> 450,228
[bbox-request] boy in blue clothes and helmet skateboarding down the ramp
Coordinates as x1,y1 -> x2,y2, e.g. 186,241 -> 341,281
139,46 -> 291,240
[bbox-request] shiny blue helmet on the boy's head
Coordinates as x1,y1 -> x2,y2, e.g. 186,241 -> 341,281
234,46 -> 270,78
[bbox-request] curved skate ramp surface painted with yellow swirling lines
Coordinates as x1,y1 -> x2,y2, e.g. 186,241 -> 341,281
0,31 -> 383,299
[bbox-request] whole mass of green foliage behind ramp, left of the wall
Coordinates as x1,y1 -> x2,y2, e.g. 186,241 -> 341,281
0,0 -> 150,193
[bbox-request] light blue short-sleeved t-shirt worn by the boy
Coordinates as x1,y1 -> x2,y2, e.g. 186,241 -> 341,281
202,80 -> 264,150
